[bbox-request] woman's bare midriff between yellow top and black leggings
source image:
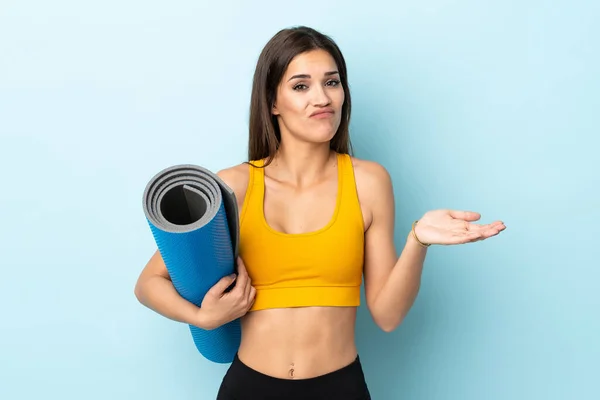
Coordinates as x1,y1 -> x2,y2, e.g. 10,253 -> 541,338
238,307 -> 357,379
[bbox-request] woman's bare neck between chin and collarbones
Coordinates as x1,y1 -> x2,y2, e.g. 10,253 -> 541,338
267,142 -> 334,186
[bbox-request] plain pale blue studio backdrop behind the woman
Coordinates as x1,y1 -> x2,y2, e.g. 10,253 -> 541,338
0,0 -> 600,400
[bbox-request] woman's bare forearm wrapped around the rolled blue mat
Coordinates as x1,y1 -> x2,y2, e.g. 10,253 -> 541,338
135,275 -> 210,328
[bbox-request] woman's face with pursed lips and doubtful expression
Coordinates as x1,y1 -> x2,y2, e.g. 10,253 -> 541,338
273,50 -> 344,143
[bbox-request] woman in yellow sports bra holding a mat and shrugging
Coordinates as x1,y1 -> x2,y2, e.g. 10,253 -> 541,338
136,27 -> 505,400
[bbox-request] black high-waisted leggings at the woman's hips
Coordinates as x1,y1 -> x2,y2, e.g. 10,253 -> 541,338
217,355 -> 371,400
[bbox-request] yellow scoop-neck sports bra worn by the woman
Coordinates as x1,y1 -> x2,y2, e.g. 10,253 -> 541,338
240,154 -> 364,311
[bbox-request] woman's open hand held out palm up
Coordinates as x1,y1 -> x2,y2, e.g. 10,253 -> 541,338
415,210 -> 506,245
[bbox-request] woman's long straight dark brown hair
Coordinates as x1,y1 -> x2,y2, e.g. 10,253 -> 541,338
248,26 -> 352,166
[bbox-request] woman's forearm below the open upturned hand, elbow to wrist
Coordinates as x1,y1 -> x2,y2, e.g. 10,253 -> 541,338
372,234 -> 427,332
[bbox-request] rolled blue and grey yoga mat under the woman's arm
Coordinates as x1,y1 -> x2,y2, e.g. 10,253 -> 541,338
143,165 -> 241,363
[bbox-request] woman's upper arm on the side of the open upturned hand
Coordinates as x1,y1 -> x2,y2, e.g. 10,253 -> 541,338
356,161 -> 398,308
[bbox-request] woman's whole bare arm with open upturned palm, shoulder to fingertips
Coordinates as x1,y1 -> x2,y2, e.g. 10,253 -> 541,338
357,161 -> 506,332
